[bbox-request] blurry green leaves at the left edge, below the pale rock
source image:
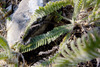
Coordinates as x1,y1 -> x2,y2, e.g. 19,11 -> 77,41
0,36 -> 18,67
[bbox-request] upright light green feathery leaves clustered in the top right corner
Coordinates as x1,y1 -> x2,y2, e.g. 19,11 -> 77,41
72,0 -> 100,23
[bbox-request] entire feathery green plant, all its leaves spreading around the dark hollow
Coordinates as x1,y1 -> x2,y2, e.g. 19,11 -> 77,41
0,0 -> 100,67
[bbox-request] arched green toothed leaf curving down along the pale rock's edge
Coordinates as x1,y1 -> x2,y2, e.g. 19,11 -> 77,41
23,1 -> 70,38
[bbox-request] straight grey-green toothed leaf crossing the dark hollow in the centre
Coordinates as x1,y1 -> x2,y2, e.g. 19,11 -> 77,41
21,24 -> 73,53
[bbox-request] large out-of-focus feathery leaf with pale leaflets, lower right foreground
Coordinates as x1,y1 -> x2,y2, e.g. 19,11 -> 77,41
54,31 -> 100,67
